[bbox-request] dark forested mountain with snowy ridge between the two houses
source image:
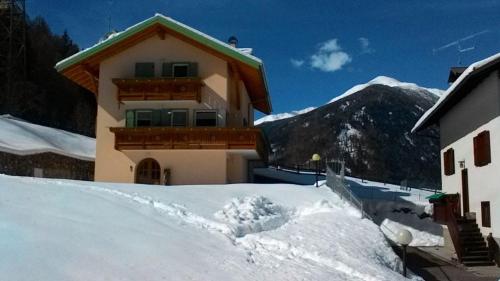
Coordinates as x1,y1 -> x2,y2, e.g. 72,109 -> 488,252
259,77 -> 440,187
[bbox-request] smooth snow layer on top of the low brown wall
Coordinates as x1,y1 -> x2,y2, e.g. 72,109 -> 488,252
0,115 -> 95,161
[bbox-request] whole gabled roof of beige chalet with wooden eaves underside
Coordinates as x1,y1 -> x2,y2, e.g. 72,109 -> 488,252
55,14 -> 272,113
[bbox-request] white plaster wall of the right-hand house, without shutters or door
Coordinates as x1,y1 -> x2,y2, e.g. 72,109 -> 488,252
440,103 -> 500,238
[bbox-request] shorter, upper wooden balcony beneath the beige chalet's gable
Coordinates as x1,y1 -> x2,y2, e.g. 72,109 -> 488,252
112,77 -> 203,102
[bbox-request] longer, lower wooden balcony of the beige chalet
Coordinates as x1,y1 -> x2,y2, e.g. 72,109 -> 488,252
110,127 -> 268,161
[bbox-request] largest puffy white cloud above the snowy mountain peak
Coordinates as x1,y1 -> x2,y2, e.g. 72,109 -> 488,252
311,39 -> 352,72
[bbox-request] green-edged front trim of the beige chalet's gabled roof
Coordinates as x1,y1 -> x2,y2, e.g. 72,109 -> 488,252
55,14 -> 263,71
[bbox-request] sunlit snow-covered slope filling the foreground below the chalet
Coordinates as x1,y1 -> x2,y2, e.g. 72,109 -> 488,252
0,175 -> 418,281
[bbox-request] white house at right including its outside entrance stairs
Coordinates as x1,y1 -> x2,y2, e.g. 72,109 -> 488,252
413,53 -> 500,265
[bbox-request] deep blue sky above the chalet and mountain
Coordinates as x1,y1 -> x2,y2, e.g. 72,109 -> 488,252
26,0 -> 500,116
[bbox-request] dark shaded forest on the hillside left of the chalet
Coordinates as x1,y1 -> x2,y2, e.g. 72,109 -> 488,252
0,4 -> 97,137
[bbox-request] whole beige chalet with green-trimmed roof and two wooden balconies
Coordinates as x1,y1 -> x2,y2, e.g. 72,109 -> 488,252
56,14 -> 271,184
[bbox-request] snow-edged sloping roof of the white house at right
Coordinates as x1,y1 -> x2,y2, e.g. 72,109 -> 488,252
411,53 -> 500,133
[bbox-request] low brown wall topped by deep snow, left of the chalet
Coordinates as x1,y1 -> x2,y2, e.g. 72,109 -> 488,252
0,115 -> 95,180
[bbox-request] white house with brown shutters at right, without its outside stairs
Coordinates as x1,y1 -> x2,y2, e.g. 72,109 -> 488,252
412,53 -> 500,264
